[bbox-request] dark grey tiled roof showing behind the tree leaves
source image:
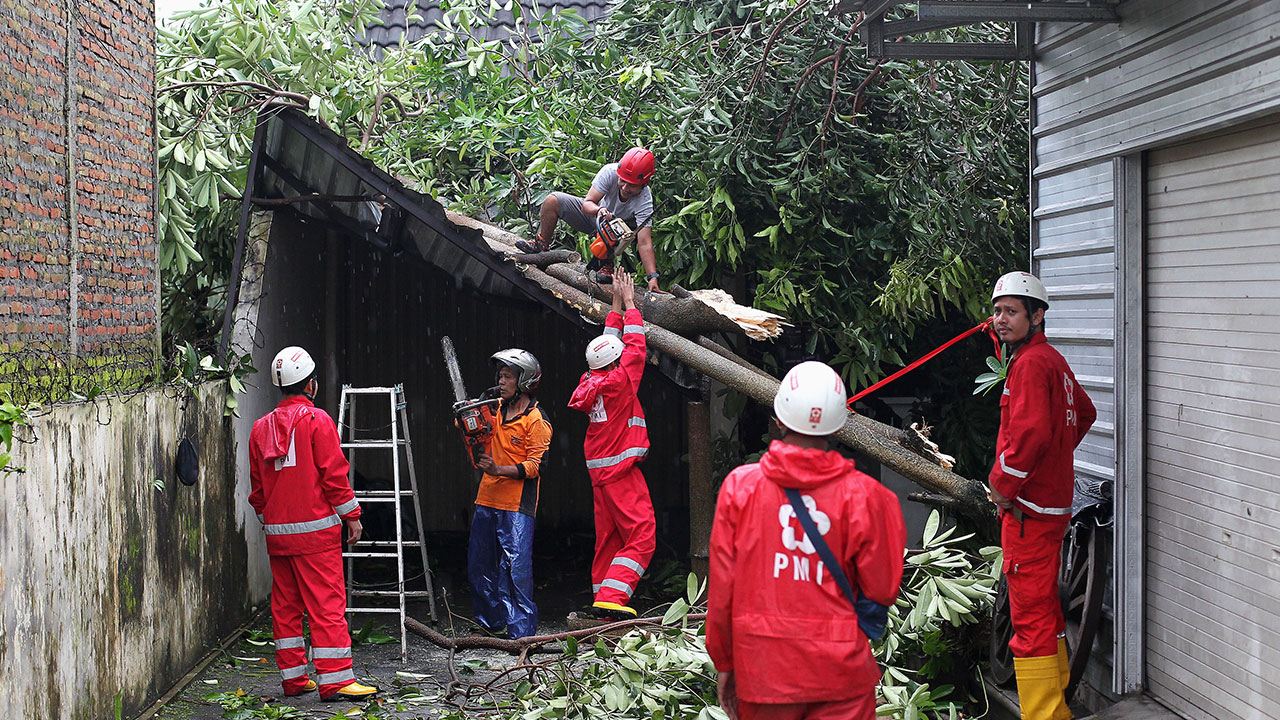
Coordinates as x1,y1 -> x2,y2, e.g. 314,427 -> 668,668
360,0 -> 609,49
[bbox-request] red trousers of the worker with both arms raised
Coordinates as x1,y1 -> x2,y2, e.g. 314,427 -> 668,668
591,466 -> 657,605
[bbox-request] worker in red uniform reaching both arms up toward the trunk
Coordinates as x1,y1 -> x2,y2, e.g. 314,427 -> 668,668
568,273 -> 657,620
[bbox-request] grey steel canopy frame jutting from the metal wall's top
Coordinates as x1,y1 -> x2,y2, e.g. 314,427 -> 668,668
832,0 -> 1120,60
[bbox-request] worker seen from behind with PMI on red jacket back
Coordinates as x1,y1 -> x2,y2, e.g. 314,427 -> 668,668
707,361 -> 906,720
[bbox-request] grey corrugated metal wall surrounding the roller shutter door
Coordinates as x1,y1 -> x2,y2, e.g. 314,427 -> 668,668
1032,0 -> 1280,702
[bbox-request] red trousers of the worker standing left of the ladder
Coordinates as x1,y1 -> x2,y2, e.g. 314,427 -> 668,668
271,546 -> 355,697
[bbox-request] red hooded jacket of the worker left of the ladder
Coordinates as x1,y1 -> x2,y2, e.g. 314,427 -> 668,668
248,395 -> 360,555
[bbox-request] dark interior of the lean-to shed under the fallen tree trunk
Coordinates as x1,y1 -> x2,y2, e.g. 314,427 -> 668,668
235,113 -> 700,620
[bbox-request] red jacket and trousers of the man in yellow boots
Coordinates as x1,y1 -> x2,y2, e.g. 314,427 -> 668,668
988,333 -> 1098,657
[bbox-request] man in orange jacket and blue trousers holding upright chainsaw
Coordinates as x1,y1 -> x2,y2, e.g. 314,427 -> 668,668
467,347 -> 552,638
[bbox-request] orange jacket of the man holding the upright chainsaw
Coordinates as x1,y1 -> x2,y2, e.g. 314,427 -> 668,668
476,397 -> 552,515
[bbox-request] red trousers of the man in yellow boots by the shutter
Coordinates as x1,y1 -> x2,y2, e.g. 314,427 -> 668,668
1000,512 -> 1068,657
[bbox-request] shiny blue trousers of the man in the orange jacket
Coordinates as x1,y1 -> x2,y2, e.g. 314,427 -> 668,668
467,505 -> 538,638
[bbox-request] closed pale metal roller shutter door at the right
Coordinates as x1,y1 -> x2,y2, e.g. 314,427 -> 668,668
1144,122 -> 1280,720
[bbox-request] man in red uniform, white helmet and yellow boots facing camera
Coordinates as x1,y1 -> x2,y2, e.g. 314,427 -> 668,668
988,273 -> 1097,720
